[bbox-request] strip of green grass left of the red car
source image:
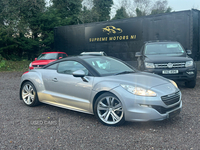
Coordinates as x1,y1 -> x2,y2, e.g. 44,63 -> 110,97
0,60 -> 31,72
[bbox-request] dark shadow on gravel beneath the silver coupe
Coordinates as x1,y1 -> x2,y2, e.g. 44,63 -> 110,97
33,104 -> 184,130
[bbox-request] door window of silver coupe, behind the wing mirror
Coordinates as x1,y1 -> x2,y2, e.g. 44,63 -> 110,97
57,61 -> 88,75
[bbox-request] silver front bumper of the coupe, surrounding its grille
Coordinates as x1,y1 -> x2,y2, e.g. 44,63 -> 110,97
110,87 -> 182,122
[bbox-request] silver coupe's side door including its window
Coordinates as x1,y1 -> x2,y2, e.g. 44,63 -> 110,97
45,61 -> 94,111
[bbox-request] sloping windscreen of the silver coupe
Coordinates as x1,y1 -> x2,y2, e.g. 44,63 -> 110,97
84,57 -> 135,76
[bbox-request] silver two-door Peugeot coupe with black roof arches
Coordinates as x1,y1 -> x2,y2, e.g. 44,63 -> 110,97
20,55 -> 182,126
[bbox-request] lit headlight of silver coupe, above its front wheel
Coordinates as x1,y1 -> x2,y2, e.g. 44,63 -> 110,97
121,84 -> 156,97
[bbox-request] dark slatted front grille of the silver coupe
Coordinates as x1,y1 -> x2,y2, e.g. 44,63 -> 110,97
161,92 -> 180,105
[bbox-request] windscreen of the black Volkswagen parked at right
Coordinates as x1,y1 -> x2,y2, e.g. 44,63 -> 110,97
144,43 -> 185,55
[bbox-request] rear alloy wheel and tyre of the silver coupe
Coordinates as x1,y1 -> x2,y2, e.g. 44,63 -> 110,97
20,82 -> 39,107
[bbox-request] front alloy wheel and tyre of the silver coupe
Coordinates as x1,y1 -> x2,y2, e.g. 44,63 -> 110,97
94,93 -> 125,126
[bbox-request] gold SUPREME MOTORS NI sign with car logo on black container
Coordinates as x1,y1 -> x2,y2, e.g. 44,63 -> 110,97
85,23 -> 141,43
